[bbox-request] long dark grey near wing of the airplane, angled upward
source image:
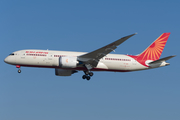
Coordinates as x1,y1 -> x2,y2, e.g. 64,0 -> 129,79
78,33 -> 136,68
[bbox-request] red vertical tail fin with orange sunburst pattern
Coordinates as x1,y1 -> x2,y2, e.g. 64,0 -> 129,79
138,33 -> 170,60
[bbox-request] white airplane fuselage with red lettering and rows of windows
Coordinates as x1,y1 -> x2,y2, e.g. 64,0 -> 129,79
4,50 -> 149,72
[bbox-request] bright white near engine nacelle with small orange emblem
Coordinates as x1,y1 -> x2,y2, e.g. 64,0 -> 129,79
59,56 -> 78,68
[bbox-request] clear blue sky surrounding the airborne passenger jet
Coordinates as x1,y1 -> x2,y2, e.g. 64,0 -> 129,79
0,0 -> 180,120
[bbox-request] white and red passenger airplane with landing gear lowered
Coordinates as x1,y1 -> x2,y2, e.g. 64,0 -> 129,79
4,33 -> 175,80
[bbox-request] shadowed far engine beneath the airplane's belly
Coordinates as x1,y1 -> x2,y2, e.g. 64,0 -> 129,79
55,68 -> 77,76
